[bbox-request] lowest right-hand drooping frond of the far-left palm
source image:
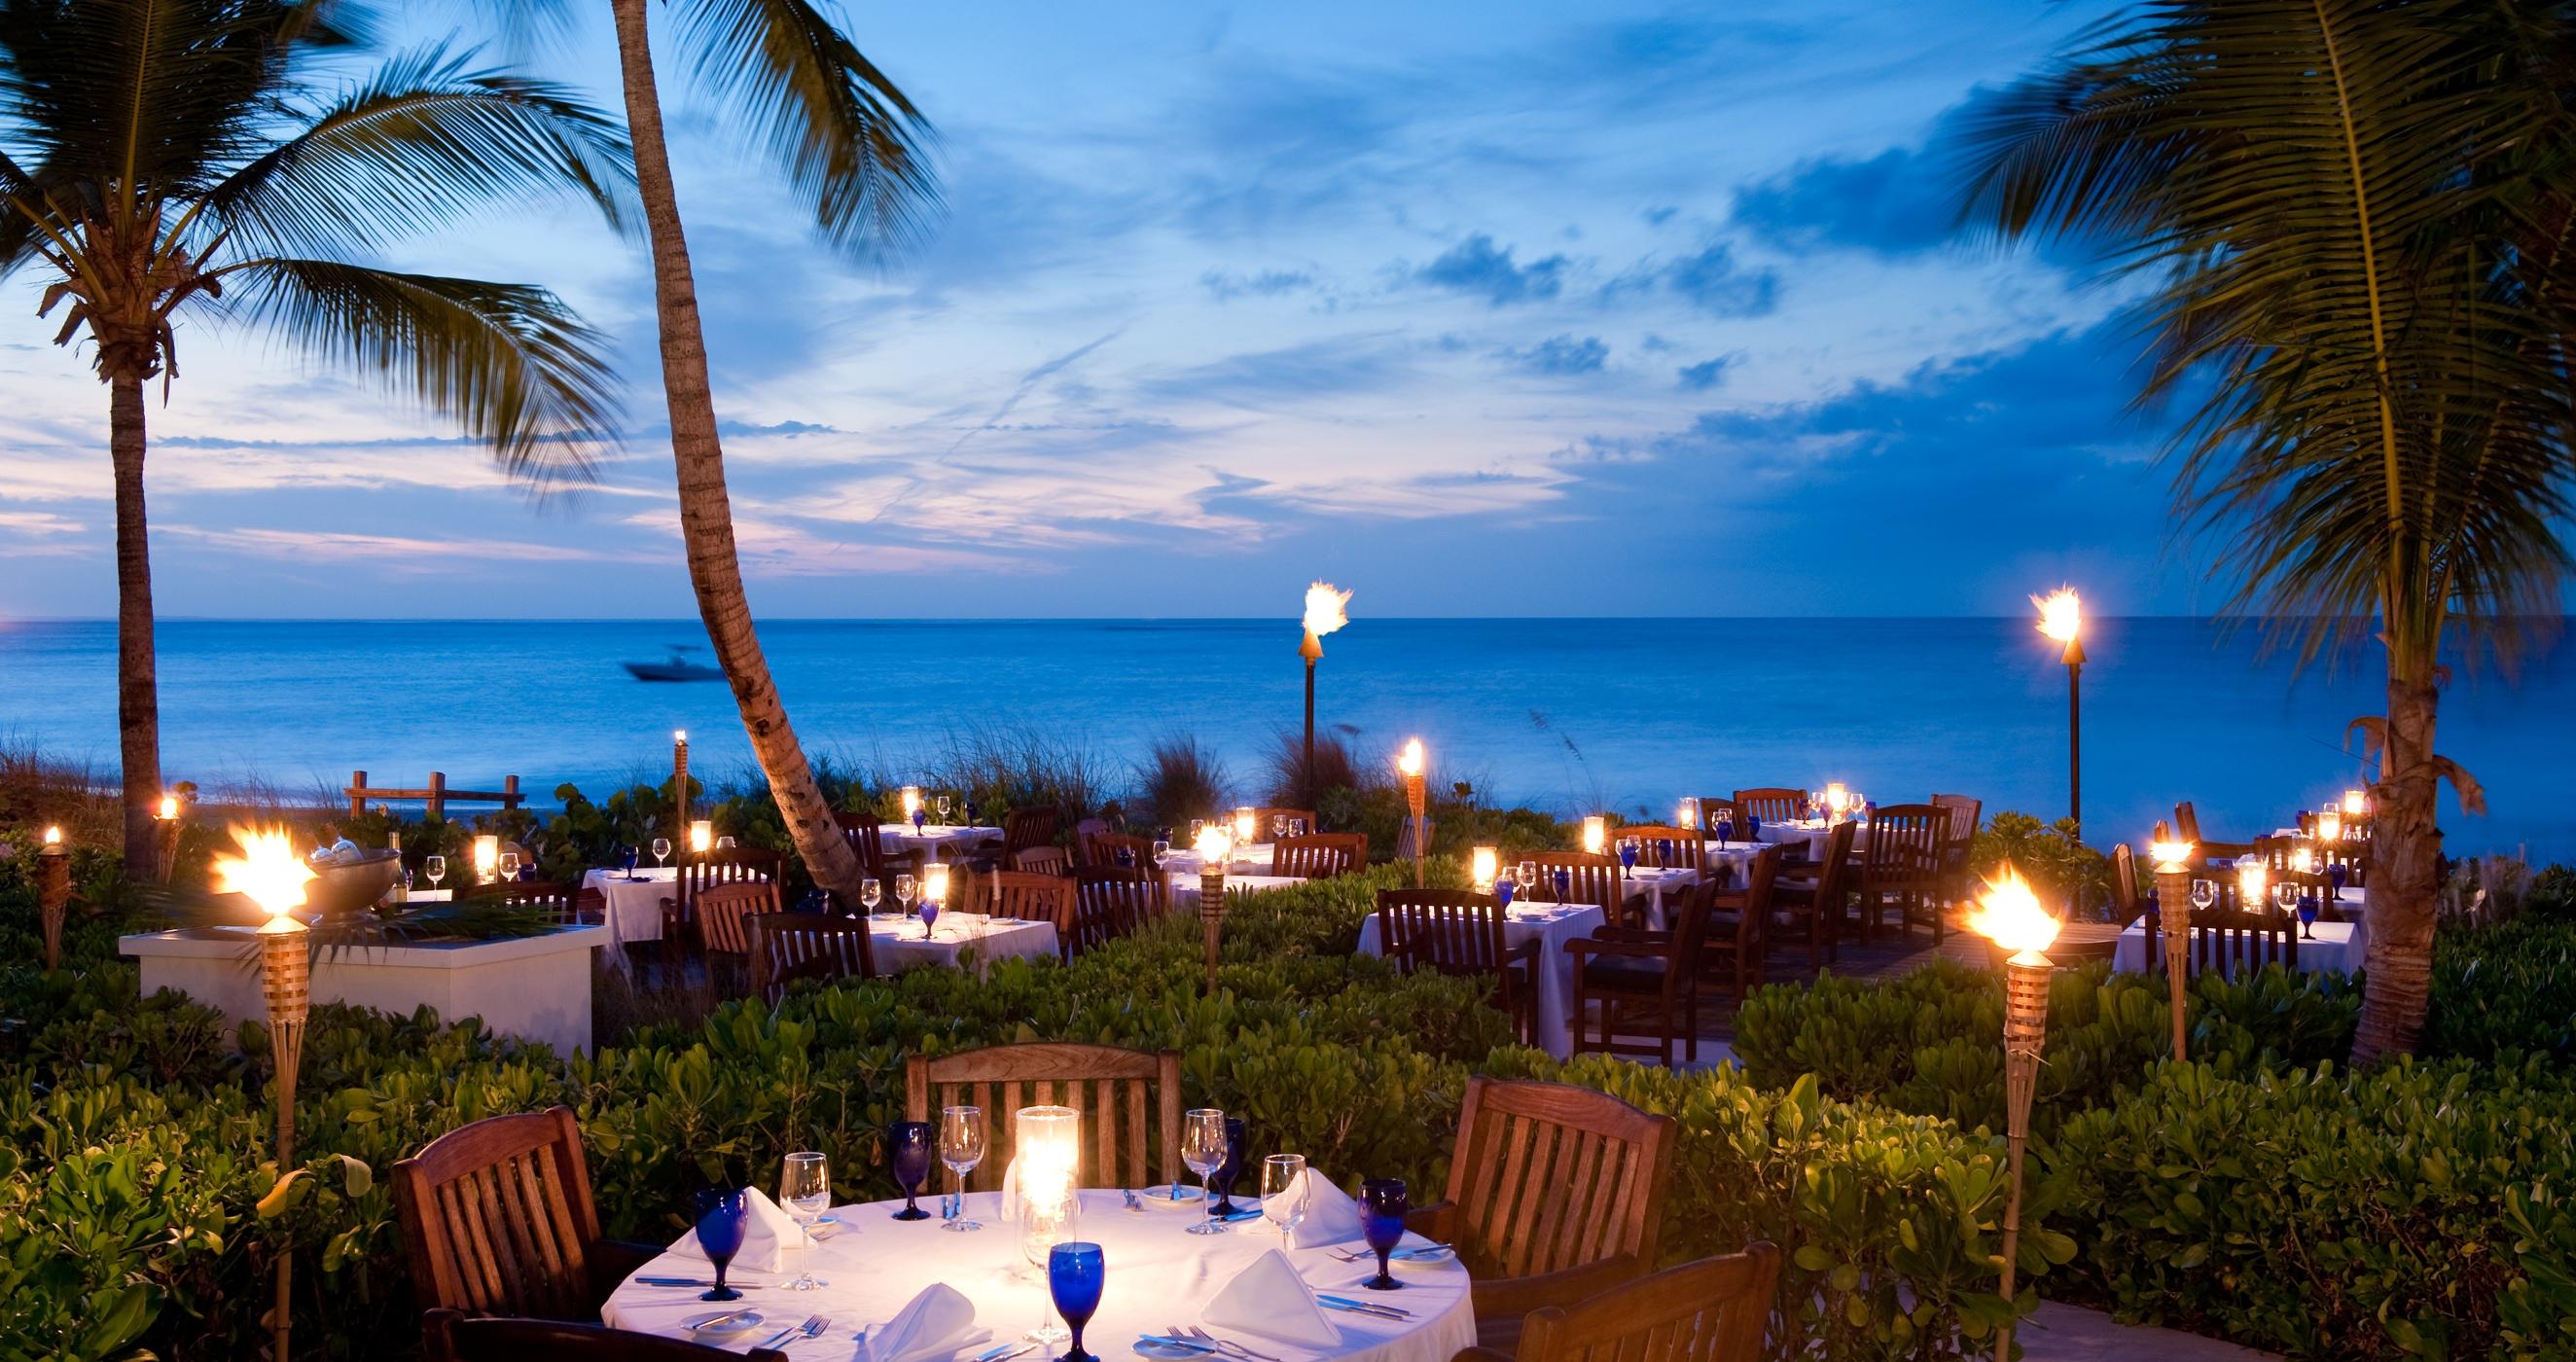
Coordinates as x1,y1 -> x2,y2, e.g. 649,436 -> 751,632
224,258 -> 619,484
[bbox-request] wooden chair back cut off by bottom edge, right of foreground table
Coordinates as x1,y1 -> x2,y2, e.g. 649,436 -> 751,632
1450,1241 -> 1780,1362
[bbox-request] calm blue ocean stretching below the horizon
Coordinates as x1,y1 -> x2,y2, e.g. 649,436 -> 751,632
0,618 -> 2576,860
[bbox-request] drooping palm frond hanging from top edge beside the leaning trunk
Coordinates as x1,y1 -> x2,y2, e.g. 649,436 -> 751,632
672,0 -> 941,255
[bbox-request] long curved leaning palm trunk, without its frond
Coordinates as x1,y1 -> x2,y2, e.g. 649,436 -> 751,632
608,0 -> 860,904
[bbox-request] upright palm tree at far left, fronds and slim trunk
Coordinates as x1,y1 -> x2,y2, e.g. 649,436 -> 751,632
0,0 -> 626,865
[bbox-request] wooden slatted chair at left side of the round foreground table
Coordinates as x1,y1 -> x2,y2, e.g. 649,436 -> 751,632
394,1107 -> 662,1321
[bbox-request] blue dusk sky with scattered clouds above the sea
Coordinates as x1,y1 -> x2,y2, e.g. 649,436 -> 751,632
0,0 -> 2221,618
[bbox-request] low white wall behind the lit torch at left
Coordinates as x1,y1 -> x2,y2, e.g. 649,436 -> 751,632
116,927 -> 608,1056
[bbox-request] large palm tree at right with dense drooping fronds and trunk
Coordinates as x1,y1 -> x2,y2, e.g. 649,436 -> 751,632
1965,0 -> 2576,1063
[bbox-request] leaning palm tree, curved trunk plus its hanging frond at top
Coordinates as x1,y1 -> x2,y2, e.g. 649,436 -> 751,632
590,0 -> 938,904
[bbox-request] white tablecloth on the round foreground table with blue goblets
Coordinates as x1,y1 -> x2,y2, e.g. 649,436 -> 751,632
600,1184 -> 1476,1362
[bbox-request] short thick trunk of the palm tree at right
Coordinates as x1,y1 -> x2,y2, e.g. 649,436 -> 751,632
2352,664 -> 2442,1063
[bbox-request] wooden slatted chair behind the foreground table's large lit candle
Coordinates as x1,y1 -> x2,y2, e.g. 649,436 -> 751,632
904,1043 -> 1182,1192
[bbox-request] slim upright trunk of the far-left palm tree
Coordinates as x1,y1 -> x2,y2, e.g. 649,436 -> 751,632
108,376 -> 160,880
